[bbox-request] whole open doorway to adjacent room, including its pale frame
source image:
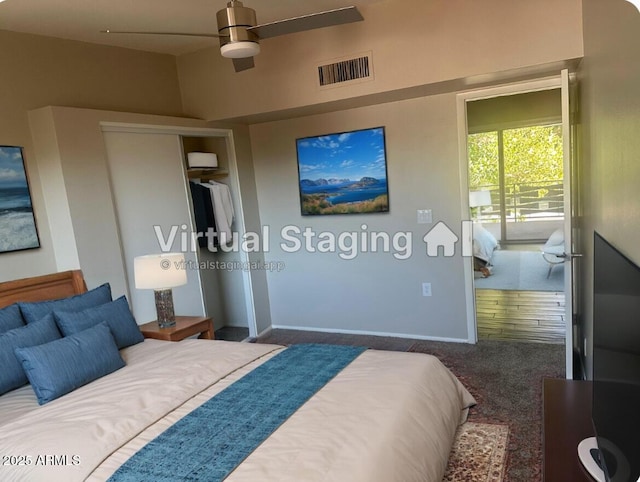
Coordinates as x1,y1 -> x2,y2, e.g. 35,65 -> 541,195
458,72 -> 573,373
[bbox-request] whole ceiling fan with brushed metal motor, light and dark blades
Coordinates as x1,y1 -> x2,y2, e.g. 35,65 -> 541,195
101,0 -> 363,72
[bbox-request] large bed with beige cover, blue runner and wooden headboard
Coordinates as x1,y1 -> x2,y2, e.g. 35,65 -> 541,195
0,271 -> 475,482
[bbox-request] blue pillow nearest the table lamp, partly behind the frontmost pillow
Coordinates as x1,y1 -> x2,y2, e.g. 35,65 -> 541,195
53,296 -> 144,348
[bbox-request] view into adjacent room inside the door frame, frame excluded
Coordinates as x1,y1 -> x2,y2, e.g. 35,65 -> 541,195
467,100 -> 565,343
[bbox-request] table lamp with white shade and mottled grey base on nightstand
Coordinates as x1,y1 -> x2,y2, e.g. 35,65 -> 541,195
133,253 -> 187,328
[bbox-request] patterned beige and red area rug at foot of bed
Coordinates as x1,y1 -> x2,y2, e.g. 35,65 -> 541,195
442,422 -> 509,482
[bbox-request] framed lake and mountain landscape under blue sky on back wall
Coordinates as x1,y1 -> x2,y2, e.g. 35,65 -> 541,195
296,127 -> 389,215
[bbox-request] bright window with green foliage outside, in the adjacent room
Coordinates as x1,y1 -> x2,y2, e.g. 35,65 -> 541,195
468,124 -> 564,244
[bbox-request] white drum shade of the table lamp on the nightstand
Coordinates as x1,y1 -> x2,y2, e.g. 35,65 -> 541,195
133,253 -> 187,290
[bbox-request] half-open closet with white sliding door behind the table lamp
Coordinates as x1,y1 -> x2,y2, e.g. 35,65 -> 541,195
102,124 -> 256,339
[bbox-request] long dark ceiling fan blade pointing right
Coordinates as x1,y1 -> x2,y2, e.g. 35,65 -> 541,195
247,6 -> 364,39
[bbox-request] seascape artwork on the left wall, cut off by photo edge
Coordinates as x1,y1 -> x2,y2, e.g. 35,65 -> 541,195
0,146 -> 40,253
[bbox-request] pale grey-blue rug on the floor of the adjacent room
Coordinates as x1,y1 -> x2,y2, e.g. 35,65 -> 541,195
475,249 -> 564,291
